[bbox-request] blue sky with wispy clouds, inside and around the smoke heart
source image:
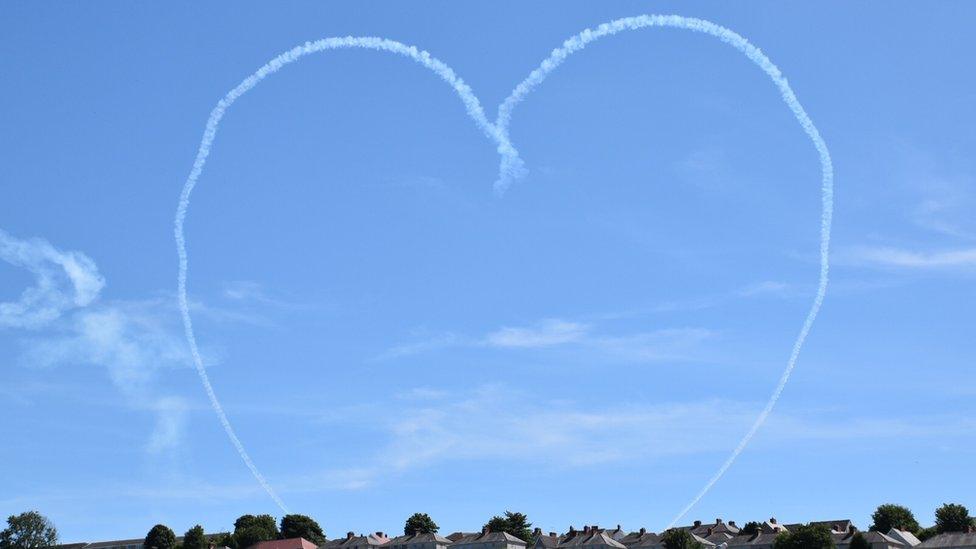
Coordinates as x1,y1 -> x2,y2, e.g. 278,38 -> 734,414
0,2 -> 976,541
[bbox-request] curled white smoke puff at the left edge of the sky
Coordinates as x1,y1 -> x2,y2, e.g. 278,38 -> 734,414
0,230 -> 105,329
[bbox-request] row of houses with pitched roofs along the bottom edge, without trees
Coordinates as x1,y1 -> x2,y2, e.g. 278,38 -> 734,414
60,518 -> 976,549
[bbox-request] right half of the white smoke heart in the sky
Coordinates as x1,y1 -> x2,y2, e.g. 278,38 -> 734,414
495,15 -> 834,528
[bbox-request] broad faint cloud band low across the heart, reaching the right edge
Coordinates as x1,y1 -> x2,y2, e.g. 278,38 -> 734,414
282,385 -> 976,491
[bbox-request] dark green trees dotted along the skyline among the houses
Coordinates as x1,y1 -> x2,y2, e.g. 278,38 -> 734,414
0,503 -> 976,549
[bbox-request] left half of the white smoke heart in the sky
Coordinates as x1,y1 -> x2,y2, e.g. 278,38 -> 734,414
174,36 -> 510,513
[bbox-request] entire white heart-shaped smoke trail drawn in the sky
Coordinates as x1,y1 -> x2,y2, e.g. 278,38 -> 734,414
174,15 -> 834,528
